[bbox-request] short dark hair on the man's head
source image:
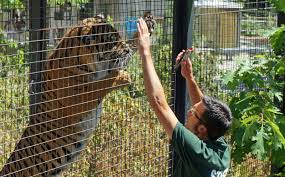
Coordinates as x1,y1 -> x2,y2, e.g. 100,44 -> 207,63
202,96 -> 232,140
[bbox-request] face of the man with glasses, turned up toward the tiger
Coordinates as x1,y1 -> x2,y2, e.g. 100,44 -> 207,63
185,101 -> 208,139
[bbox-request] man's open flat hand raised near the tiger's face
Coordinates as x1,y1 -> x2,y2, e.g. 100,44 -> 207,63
137,18 -> 150,58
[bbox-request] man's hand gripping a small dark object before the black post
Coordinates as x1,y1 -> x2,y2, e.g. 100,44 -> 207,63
176,50 -> 194,79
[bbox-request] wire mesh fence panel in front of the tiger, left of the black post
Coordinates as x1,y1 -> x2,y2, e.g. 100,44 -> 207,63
0,0 -> 173,176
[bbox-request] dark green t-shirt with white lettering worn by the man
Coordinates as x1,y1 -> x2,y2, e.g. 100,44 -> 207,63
172,122 -> 230,177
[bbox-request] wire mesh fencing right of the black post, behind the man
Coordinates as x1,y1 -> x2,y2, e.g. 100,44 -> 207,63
193,0 -> 277,176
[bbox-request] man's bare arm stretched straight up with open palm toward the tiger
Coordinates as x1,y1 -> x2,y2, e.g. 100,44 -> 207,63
138,19 -> 178,139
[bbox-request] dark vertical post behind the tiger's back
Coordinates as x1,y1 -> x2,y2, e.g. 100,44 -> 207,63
29,0 -> 46,115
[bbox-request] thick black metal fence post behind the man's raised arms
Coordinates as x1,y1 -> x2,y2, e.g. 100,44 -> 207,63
169,0 -> 194,176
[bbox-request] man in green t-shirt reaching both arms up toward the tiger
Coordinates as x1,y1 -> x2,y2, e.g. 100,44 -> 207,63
137,19 -> 232,177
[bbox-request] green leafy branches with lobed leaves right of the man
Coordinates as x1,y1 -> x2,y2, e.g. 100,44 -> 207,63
223,0 -> 285,171
